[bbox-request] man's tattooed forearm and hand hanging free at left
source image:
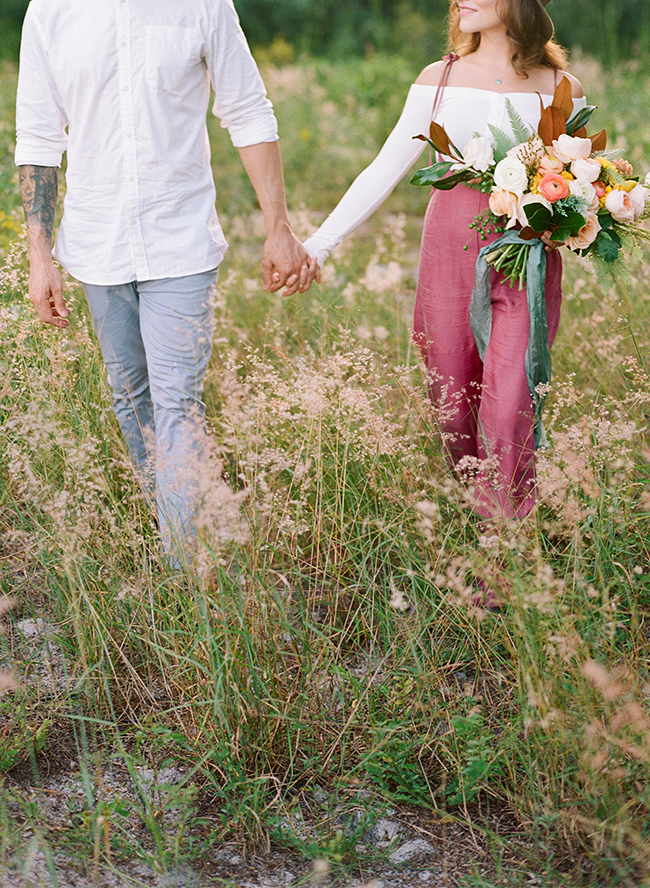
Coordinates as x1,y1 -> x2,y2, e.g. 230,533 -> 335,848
18,166 -> 70,327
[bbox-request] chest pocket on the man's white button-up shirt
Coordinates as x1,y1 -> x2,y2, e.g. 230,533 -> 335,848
145,25 -> 205,92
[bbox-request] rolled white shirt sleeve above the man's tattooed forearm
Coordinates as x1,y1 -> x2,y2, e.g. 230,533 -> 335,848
15,8 -> 68,167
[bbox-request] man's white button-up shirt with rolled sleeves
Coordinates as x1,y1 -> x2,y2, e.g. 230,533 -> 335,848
15,0 -> 278,285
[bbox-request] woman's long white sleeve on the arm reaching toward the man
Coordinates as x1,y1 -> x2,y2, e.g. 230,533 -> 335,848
305,83 -> 436,265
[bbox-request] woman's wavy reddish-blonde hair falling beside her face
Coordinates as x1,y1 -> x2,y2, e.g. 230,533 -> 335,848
449,0 -> 567,77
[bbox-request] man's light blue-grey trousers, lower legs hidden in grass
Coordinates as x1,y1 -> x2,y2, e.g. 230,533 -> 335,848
83,269 -> 217,566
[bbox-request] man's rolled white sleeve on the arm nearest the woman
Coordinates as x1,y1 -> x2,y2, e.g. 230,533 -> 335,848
205,0 -> 278,148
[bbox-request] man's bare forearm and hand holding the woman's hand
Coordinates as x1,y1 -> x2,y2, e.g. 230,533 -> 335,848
238,142 -> 320,296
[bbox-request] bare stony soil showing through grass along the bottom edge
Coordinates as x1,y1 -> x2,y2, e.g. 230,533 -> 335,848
0,619 -> 536,888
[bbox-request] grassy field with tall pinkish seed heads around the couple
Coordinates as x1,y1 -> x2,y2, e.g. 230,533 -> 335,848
0,50 -> 650,888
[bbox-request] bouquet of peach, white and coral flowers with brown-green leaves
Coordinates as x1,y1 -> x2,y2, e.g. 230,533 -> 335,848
411,77 -> 650,288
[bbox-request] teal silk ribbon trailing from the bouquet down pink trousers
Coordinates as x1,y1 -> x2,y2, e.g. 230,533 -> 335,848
469,231 -> 551,450
